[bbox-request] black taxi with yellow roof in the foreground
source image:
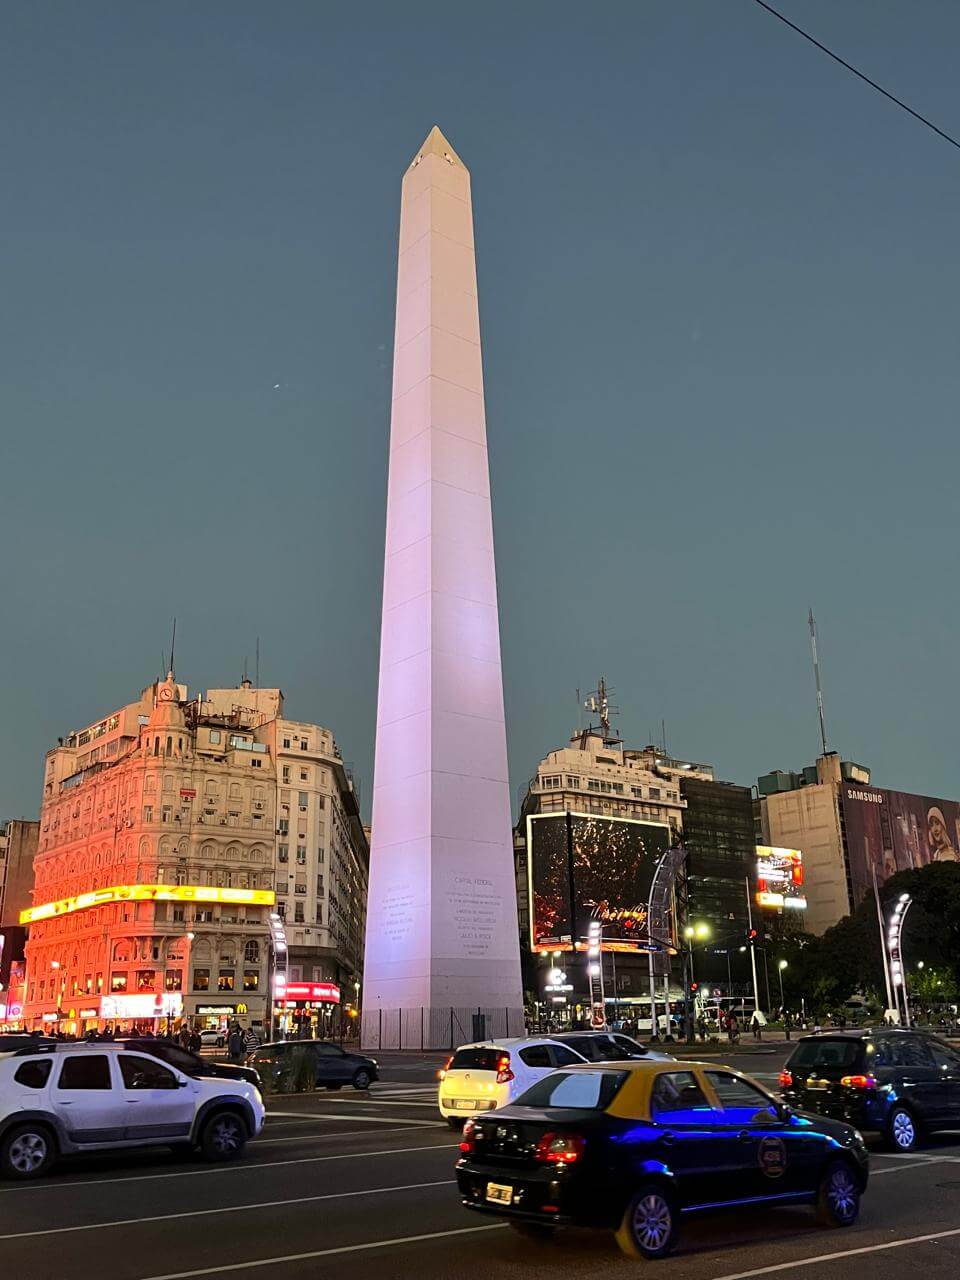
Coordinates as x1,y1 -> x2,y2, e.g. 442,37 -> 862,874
457,1061 -> 868,1258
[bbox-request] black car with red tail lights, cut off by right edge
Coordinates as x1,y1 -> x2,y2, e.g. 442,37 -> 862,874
780,1027 -> 960,1151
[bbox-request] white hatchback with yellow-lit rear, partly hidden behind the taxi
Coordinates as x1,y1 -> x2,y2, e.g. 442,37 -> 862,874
438,1036 -> 586,1129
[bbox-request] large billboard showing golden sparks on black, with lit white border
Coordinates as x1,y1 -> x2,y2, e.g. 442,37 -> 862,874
526,813 -> 669,951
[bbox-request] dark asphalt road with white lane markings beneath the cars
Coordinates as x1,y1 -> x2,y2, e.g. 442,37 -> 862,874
0,1048 -> 960,1280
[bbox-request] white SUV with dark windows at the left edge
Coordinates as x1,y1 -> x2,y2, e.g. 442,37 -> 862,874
0,1043 -> 264,1178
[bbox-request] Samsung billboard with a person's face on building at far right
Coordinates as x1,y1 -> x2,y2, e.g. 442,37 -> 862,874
840,782 -> 960,905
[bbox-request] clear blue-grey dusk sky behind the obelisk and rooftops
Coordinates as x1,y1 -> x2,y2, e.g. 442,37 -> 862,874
0,0 -> 960,817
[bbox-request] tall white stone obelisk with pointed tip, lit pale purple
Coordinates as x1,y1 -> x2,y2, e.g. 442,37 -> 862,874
362,127 -> 524,1048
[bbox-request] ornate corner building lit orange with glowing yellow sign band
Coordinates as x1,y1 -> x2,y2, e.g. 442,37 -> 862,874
22,673 -> 276,1033
